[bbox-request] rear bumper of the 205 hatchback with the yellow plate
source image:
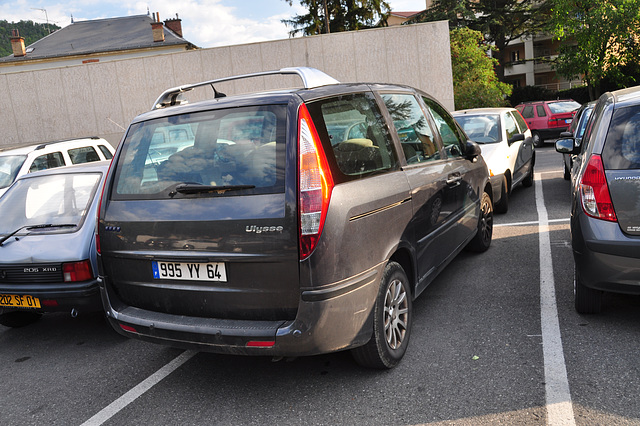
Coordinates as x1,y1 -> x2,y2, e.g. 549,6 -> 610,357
0,278 -> 102,312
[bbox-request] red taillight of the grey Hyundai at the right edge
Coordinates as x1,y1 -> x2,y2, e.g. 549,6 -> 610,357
580,155 -> 618,222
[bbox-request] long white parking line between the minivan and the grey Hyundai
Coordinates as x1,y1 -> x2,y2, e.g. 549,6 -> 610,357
535,173 -> 576,426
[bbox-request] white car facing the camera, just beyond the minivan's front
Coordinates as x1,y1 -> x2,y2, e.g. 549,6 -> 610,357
453,108 -> 536,213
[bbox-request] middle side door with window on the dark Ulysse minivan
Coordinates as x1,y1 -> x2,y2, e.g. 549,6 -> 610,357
381,93 -> 460,286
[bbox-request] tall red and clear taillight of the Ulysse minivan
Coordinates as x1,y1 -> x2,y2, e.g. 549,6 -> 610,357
298,104 -> 333,259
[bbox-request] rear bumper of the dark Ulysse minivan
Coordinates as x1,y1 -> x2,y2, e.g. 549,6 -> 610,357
100,265 -> 384,356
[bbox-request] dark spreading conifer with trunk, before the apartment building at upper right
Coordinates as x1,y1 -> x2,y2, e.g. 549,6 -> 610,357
407,0 -> 551,81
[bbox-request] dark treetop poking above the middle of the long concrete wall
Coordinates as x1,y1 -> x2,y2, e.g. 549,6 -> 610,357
282,0 -> 391,37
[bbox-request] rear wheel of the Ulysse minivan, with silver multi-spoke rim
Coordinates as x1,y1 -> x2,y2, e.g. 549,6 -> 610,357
351,261 -> 413,369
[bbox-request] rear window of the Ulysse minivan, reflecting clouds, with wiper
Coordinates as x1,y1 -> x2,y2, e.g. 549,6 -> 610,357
113,105 -> 286,199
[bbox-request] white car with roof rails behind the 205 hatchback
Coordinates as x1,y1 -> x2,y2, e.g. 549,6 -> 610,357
0,137 -> 115,197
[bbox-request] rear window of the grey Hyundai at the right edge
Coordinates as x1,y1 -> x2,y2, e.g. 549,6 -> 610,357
602,105 -> 640,170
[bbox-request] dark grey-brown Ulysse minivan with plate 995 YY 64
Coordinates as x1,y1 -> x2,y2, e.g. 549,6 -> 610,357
98,68 -> 493,368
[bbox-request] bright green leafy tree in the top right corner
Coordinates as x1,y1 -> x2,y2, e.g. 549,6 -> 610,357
553,0 -> 640,99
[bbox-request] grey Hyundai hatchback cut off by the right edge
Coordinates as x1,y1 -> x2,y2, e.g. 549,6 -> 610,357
556,86 -> 640,314
